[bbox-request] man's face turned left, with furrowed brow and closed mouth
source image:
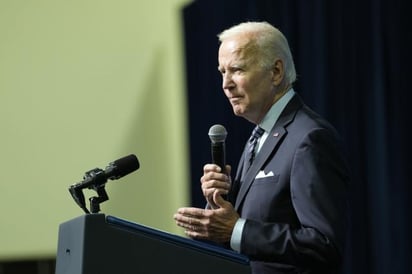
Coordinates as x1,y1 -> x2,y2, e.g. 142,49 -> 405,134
218,36 -> 276,124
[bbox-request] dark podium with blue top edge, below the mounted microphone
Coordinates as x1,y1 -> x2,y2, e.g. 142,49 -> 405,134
56,214 -> 251,274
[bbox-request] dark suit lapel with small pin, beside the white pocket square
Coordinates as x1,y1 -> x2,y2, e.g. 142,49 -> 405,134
235,95 -> 302,210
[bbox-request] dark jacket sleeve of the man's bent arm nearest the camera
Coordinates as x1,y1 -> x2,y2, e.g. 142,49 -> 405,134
241,129 -> 349,267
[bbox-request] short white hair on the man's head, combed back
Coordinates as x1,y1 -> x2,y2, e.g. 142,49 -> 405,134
218,22 -> 296,84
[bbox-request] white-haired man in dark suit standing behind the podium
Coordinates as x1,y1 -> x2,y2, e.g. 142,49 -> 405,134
174,22 -> 349,274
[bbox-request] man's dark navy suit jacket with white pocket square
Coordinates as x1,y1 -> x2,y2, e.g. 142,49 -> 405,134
228,95 -> 349,274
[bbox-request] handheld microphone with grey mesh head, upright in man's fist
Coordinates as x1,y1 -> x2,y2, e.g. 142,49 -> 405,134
209,125 -> 227,173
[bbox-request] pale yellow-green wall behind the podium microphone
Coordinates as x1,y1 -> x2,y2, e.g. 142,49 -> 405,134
0,0 -> 189,260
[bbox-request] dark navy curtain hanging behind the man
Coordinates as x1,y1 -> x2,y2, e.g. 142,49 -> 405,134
183,0 -> 412,274
